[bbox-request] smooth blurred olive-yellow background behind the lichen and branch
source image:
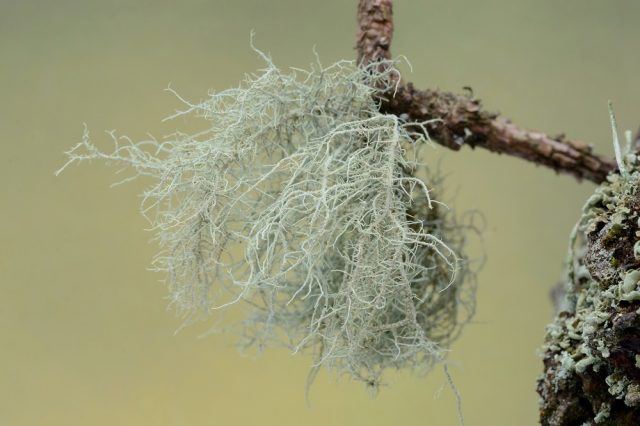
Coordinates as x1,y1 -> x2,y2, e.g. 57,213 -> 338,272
0,0 -> 640,426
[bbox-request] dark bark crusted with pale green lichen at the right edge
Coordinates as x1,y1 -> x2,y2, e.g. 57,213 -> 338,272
538,111 -> 640,425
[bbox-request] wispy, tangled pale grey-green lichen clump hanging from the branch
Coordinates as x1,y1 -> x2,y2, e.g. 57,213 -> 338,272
56,50 -> 473,387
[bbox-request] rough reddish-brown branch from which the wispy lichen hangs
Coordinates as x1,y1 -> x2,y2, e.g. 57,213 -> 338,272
357,0 -> 617,183
